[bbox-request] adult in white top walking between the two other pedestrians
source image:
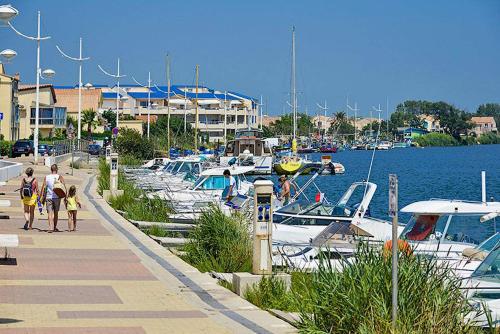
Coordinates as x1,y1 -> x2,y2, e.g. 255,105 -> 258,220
42,164 -> 66,233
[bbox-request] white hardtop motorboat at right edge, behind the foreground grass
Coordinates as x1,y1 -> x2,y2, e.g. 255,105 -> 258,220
400,199 -> 500,260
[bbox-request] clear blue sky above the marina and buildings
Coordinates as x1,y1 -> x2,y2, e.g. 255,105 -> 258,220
0,0 -> 500,115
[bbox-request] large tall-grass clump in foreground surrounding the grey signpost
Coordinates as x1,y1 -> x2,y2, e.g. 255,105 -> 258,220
296,244 -> 477,334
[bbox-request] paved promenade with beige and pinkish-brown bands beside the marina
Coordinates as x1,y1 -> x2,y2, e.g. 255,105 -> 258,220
0,158 -> 295,334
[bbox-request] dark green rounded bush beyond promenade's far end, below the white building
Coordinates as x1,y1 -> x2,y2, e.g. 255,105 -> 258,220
114,129 -> 154,160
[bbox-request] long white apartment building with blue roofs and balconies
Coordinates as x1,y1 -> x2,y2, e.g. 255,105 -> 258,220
95,84 -> 260,142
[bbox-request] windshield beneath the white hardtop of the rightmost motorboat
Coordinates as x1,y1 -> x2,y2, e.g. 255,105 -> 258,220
401,214 -> 496,244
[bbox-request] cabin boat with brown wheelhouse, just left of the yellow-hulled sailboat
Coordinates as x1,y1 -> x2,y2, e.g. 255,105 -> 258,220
220,129 -> 273,174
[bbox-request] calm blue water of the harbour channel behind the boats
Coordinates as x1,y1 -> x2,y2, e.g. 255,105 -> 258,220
272,145 -> 500,223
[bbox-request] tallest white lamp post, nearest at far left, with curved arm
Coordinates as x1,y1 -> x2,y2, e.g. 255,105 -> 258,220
0,5 -> 55,165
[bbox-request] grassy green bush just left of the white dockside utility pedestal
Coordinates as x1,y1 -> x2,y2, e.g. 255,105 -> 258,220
183,206 -> 252,272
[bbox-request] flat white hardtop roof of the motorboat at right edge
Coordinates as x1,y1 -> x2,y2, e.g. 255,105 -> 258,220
401,199 -> 500,215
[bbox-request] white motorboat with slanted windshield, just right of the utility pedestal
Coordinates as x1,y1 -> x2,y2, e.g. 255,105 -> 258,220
273,182 -> 402,269
